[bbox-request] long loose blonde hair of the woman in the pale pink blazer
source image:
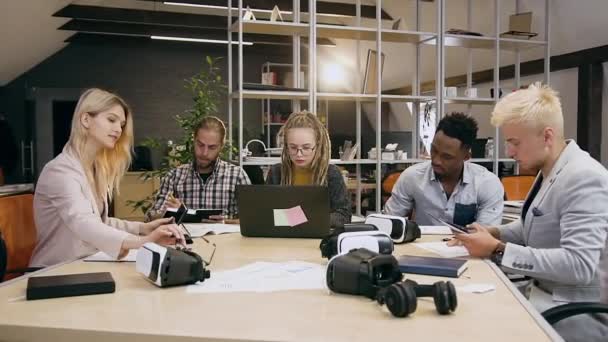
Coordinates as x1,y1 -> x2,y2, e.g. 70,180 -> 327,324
67,88 -> 133,203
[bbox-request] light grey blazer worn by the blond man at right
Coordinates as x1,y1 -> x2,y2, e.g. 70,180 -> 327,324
499,140 -> 608,302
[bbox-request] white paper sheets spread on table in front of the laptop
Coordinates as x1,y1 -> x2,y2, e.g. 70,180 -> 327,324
186,261 -> 326,293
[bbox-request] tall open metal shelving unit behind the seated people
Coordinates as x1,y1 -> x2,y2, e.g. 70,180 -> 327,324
227,0 -> 550,214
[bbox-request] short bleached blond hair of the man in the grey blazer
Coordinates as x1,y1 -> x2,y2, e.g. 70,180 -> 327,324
491,82 -> 564,138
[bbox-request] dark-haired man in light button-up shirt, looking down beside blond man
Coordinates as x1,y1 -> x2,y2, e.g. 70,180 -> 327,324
384,113 -> 504,225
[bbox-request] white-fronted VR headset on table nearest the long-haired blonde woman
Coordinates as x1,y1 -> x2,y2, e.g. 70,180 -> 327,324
135,242 -> 210,287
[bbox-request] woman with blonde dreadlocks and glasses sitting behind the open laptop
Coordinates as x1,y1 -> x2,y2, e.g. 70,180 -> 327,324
266,112 -> 351,227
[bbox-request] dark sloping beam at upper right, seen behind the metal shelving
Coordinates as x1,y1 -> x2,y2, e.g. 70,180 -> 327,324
386,45 -> 608,95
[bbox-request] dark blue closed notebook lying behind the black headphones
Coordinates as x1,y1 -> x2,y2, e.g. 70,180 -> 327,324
397,255 -> 468,278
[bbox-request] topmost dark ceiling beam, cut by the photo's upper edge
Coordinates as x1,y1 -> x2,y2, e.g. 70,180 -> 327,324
140,0 -> 393,20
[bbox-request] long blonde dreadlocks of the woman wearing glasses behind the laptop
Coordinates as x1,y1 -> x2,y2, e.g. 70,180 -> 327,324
279,112 -> 331,185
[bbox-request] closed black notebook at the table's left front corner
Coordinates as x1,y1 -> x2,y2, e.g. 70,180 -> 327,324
25,272 -> 116,300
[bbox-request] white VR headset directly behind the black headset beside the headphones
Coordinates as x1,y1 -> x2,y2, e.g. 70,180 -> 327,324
337,230 -> 393,255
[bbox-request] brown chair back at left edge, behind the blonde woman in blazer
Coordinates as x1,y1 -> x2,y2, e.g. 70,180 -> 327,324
0,194 -> 39,282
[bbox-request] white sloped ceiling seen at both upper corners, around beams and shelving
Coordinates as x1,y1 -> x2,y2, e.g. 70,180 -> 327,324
0,0 -> 608,89
